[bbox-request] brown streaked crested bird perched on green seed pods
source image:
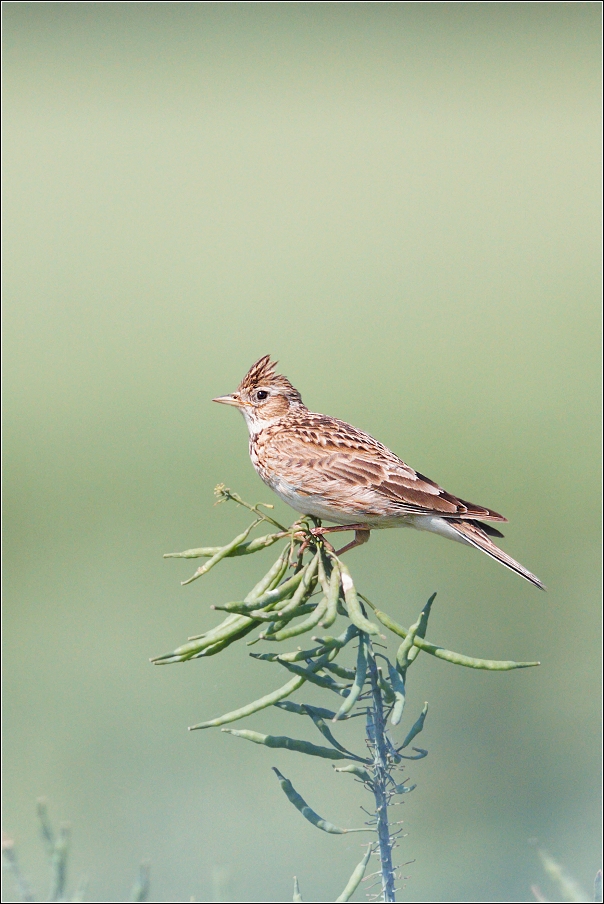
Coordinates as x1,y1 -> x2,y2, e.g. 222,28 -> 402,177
212,355 -> 546,590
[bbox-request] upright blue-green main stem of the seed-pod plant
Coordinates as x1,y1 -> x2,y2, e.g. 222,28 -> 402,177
367,646 -> 396,901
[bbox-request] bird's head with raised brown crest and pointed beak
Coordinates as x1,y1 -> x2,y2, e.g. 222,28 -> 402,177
212,355 -> 304,433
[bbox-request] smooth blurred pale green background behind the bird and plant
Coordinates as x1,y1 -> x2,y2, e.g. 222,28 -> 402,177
2,2 -> 601,901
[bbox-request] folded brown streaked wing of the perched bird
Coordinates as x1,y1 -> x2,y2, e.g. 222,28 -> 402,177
265,411 -> 507,521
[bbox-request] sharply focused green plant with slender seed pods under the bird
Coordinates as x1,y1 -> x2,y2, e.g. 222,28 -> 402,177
152,485 -> 539,901
